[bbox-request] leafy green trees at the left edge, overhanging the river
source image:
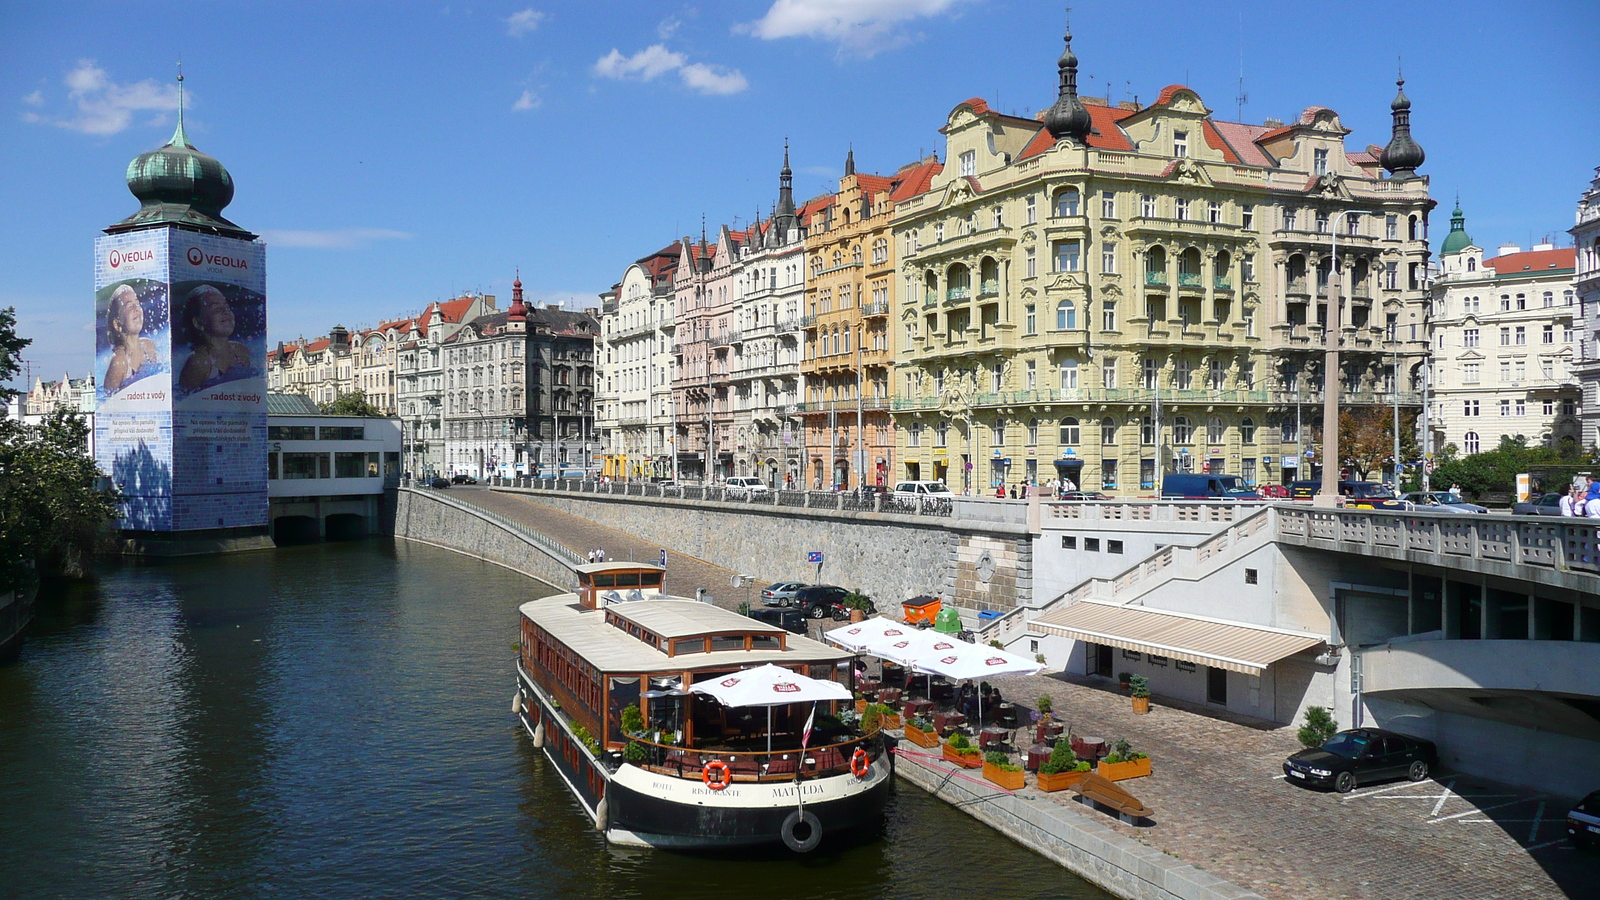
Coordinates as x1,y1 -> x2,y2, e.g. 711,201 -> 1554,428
0,408 -> 118,589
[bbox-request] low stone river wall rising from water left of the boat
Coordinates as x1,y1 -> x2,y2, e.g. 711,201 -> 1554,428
394,490 -> 576,591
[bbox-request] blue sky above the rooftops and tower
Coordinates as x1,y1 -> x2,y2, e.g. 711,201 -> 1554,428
0,0 -> 1600,389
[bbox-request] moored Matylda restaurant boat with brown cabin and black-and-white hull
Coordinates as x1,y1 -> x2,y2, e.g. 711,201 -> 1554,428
515,562 -> 893,852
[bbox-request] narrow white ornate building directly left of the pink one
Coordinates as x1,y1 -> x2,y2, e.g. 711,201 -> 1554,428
595,243 -> 678,479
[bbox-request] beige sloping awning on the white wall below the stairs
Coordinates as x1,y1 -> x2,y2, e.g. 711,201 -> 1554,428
1029,601 -> 1326,676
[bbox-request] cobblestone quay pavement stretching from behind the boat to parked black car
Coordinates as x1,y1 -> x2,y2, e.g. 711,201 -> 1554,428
438,490 -> 1600,900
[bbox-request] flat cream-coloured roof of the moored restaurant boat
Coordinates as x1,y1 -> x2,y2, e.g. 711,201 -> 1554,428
520,594 -> 851,673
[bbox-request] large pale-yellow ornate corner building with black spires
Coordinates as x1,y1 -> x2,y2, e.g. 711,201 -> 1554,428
896,34 -> 1434,496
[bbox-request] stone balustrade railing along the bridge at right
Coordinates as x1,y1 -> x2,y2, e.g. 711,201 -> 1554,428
1278,504 -> 1600,575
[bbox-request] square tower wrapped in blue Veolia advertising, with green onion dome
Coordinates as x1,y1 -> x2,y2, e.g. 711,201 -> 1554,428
94,74 -> 267,534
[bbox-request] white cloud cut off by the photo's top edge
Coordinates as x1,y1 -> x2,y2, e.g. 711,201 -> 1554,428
736,0 -> 966,56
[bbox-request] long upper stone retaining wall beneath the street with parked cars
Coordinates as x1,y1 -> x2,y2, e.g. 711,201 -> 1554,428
496,488 -> 1034,612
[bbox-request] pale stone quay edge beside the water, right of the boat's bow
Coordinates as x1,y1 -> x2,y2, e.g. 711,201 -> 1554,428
894,745 -> 1264,900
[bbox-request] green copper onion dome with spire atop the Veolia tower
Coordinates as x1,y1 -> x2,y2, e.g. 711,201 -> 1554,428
106,75 -> 256,240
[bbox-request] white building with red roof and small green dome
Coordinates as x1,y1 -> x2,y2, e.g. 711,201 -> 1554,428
1427,205 -> 1582,453
